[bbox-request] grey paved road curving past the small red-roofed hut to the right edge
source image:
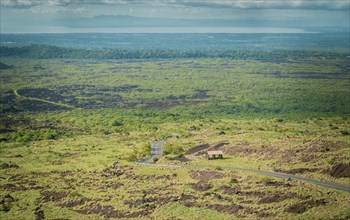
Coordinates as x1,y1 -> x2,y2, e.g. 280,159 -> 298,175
139,141 -> 350,192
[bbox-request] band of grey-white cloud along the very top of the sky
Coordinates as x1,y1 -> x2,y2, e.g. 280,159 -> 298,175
0,0 -> 350,10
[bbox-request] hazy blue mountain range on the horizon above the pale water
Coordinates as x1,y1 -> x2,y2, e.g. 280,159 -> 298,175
52,15 -> 348,32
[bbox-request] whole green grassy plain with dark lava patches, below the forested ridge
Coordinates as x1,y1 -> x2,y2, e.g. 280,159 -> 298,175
0,56 -> 350,219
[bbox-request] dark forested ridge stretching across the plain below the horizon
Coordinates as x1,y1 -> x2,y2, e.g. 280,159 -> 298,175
0,45 -> 344,61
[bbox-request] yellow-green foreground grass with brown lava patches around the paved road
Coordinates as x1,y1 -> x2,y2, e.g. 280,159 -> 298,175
0,118 -> 350,219
